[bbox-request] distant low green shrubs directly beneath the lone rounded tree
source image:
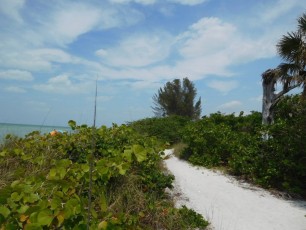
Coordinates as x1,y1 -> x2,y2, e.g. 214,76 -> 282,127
128,116 -> 190,144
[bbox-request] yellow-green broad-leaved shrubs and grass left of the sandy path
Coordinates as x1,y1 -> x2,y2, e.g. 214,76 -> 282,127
0,124 -> 207,230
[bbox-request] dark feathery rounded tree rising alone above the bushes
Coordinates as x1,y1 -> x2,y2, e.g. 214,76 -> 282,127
152,78 -> 201,119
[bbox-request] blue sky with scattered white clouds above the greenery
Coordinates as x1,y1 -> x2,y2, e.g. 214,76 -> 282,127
0,0 -> 306,125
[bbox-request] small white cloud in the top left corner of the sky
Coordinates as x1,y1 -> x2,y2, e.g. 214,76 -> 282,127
0,0 -> 25,23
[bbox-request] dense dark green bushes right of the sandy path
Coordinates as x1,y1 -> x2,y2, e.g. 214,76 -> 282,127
180,95 -> 306,197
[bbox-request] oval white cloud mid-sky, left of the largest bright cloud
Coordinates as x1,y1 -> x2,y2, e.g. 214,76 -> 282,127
96,32 -> 172,67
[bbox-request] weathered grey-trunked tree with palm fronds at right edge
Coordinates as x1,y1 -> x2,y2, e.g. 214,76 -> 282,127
262,14 -> 306,125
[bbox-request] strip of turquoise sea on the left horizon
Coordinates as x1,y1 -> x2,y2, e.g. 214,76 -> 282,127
0,123 -> 71,142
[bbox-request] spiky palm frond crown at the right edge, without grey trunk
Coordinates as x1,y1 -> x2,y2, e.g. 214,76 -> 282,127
277,13 -> 306,98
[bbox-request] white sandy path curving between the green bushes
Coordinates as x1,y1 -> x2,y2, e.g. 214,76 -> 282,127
165,150 -> 306,230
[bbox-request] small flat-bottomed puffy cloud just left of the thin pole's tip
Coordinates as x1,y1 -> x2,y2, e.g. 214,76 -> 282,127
33,74 -> 93,94
